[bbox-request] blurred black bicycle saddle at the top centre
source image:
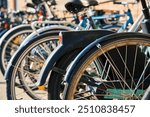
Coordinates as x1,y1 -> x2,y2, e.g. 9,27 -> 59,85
65,0 -> 98,13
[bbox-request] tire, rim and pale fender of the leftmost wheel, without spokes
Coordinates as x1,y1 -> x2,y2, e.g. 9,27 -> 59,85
0,25 -> 33,75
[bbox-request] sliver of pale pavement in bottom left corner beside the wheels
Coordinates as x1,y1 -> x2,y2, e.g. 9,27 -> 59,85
0,72 -> 6,100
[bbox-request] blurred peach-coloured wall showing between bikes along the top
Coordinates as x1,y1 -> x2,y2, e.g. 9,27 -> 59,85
0,0 -> 141,20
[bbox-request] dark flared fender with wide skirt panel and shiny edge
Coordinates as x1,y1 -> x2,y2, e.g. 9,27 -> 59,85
37,30 -> 114,85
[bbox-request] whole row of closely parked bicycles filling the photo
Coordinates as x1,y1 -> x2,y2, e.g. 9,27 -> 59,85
0,0 -> 150,100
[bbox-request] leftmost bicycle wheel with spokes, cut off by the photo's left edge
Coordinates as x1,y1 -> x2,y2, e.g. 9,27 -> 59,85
0,25 -> 33,74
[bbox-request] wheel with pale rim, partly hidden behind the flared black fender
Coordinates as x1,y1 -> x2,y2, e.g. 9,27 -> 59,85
5,30 -> 62,100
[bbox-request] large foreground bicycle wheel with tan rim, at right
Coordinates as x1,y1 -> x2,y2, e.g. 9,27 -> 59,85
64,33 -> 150,100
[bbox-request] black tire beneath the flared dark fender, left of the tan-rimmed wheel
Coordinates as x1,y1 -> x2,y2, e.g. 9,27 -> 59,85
48,49 -> 81,100
